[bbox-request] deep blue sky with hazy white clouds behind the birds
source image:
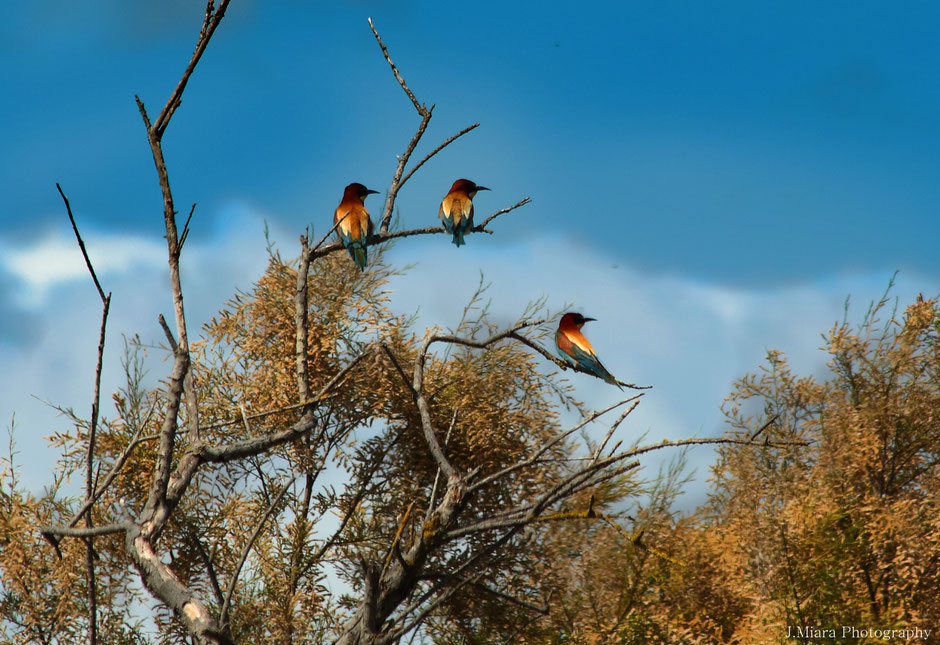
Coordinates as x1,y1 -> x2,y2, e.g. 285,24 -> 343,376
0,0 -> 940,498
